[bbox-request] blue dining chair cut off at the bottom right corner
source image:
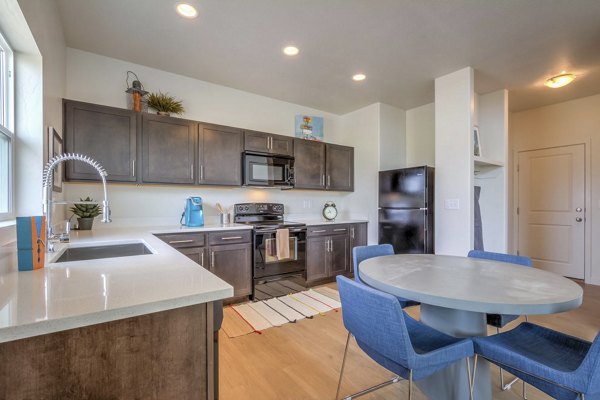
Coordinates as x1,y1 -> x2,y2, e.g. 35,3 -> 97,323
473,322 -> 600,400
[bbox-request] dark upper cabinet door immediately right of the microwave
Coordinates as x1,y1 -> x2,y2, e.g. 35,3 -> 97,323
294,139 -> 325,189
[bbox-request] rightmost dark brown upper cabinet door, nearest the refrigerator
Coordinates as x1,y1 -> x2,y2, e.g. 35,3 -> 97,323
326,144 -> 354,192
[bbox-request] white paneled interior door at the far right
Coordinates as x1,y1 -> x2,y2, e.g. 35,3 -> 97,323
517,144 -> 585,279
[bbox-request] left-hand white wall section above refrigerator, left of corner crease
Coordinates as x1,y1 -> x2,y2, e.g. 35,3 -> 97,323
379,103 -> 406,171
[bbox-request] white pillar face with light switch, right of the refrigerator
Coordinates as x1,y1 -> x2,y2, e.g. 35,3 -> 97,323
435,67 -> 474,256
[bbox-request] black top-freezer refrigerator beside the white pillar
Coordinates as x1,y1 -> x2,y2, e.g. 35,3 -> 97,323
379,166 -> 435,254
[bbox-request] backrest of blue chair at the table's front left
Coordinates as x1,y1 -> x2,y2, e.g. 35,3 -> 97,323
336,275 -> 416,367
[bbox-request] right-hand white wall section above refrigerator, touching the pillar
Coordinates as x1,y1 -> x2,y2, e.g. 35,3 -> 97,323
406,103 -> 435,167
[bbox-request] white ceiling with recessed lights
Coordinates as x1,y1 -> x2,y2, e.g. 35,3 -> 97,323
57,0 -> 600,114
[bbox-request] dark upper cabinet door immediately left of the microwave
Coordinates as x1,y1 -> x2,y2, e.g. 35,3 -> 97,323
198,124 -> 242,186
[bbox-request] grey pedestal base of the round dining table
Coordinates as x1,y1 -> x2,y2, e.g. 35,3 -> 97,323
415,304 -> 492,400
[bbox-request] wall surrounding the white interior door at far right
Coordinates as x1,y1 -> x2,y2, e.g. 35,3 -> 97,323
509,95 -> 600,285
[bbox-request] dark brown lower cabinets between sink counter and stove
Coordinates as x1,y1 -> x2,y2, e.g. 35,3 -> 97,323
156,230 -> 252,297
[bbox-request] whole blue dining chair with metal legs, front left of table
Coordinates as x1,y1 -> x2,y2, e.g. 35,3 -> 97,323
335,275 -> 473,400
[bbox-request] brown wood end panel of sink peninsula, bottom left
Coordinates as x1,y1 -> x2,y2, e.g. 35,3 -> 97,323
0,303 -> 213,400
